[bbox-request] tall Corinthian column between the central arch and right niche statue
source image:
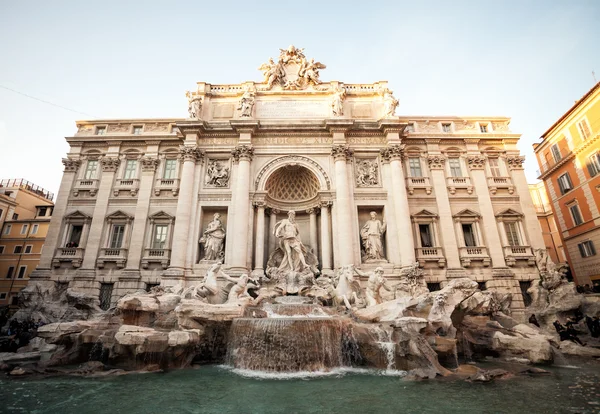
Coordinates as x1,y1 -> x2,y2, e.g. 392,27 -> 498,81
331,145 -> 354,266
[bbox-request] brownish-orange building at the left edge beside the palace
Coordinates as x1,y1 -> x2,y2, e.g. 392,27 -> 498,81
0,179 -> 54,306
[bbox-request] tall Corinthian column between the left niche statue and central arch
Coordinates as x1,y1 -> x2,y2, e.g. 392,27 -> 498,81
229,145 -> 254,272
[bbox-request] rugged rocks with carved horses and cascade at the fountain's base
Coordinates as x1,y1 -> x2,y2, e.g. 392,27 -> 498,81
0,258 -> 600,380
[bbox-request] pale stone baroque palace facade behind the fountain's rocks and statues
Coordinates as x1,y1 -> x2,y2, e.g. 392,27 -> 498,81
32,46 -> 544,311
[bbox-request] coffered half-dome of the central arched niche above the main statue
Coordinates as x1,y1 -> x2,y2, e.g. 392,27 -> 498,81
265,164 -> 321,208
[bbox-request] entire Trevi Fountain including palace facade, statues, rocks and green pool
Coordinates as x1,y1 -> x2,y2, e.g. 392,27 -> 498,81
0,46 -> 600,413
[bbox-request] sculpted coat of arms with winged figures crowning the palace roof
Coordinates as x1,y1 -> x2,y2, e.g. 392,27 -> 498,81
258,46 -> 326,90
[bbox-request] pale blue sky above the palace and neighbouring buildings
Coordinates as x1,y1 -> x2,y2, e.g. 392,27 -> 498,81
0,0 -> 600,196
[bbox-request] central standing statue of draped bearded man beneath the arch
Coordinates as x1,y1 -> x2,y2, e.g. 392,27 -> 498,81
275,211 -> 308,272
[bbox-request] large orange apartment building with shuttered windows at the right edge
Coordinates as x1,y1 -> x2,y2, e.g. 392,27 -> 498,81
533,82 -> 600,285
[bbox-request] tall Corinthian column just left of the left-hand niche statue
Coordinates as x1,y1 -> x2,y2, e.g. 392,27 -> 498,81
164,145 -> 204,276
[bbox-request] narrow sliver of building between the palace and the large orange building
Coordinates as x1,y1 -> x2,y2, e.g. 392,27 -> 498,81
529,181 -> 567,263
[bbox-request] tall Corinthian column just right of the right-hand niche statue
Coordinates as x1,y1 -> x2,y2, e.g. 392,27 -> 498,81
384,144 -> 415,267
